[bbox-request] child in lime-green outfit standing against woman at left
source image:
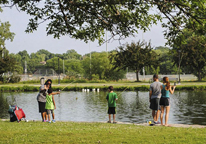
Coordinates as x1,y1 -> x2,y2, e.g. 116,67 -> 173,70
45,88 -> 56,123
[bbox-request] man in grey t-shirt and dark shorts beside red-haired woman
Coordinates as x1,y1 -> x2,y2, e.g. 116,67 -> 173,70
149,74 -> 163,124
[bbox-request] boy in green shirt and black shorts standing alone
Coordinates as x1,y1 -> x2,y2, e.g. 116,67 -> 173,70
106,86 -> 118,123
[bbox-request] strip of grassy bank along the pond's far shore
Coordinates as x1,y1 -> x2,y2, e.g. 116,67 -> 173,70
0,83 -> 206,92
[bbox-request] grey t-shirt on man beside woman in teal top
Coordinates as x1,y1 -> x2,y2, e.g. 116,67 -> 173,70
150,81 -> 162,99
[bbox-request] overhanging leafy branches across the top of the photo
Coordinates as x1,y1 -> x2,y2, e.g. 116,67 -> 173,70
1,0 -> 206,43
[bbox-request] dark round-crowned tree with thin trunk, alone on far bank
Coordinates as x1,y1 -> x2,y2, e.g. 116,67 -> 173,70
109,41 -> 158,81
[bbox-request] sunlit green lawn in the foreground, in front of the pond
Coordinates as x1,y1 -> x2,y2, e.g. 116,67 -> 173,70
0,121 -> 206,144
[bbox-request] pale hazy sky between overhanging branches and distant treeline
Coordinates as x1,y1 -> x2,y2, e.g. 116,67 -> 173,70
0,7 -> 166,55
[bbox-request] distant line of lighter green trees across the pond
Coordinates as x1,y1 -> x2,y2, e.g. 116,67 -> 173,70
1,46 -> 191,80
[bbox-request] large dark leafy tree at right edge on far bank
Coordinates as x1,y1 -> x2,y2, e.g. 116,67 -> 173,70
172,29 -> 206,81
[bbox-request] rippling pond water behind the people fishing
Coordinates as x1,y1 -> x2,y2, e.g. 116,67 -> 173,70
0,91 -> 206,125
